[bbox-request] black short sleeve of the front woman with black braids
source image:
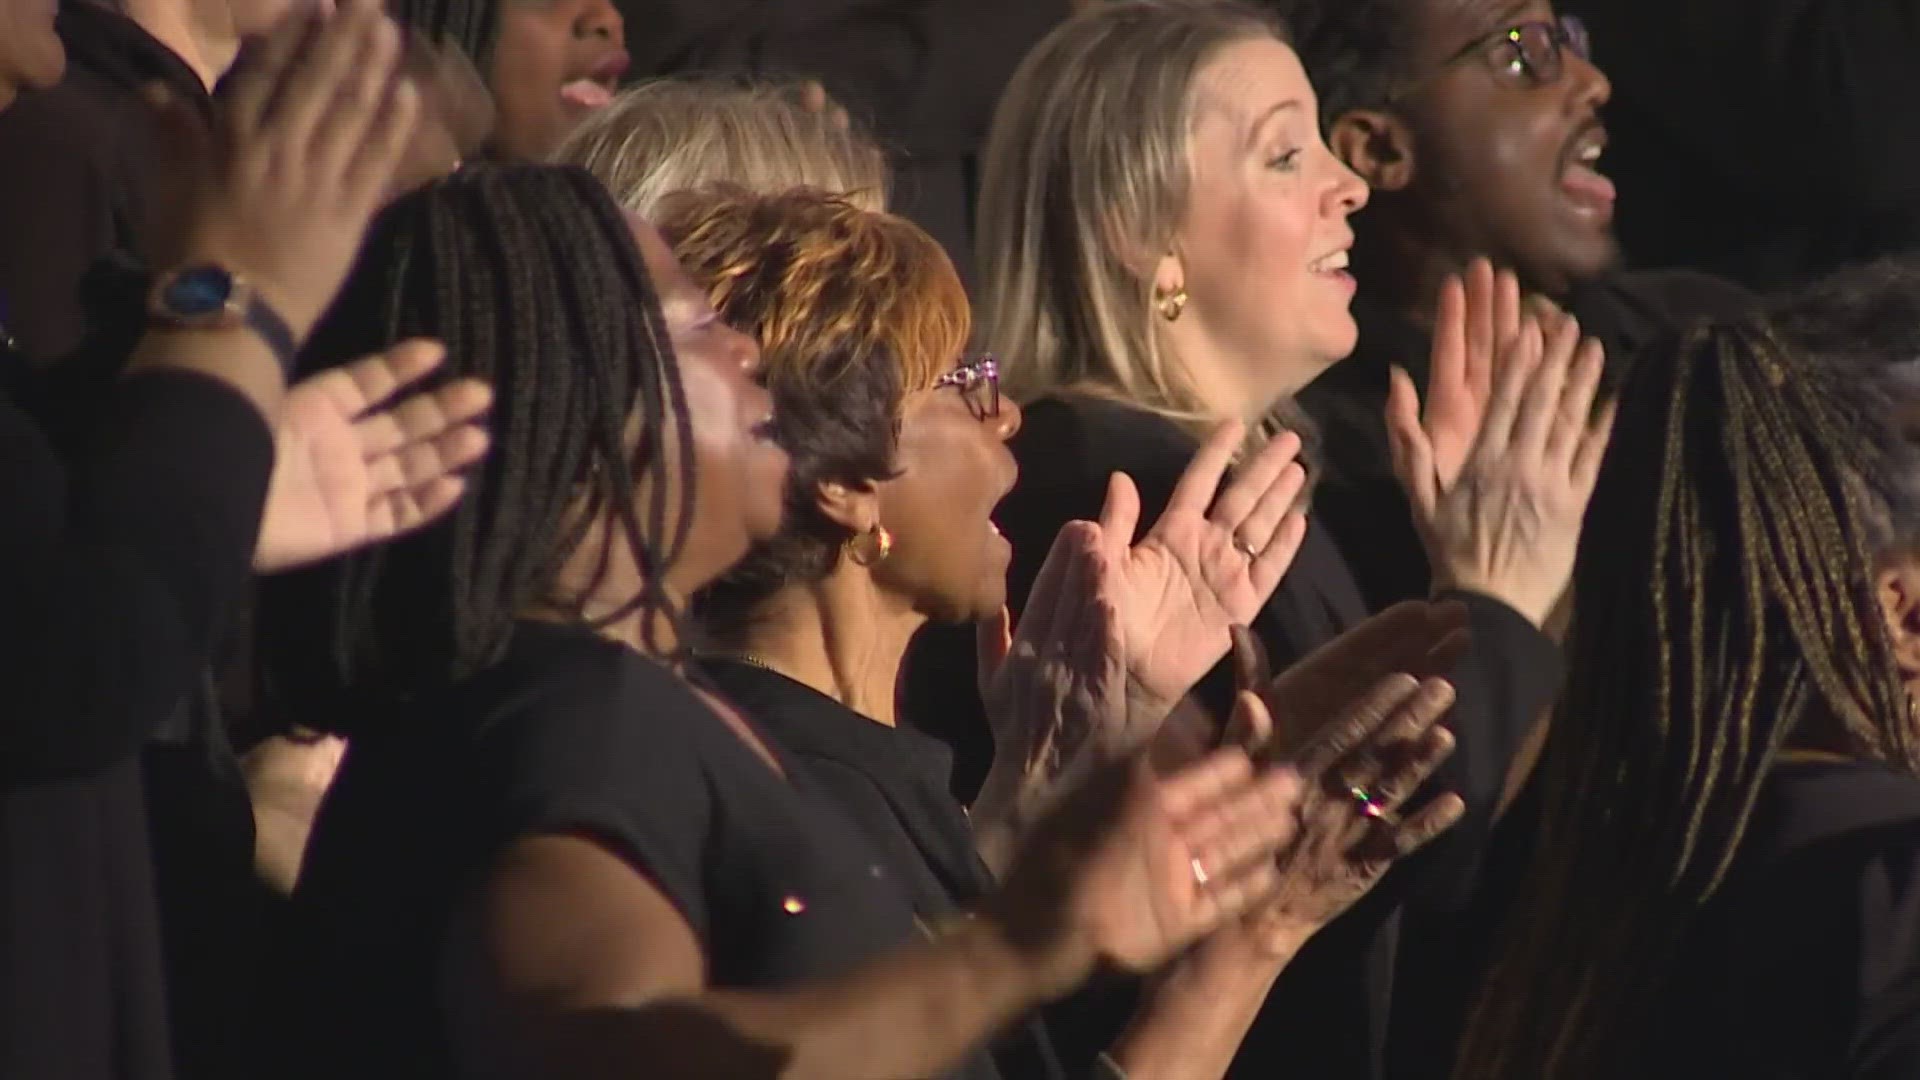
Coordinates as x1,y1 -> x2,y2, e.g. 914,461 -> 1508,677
486,644 -> 732,942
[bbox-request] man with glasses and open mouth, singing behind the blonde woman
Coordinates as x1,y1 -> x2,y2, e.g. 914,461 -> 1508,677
1265,0 -> 1745,607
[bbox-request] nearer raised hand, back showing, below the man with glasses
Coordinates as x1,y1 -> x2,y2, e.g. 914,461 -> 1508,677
1388,305 -> 1613,626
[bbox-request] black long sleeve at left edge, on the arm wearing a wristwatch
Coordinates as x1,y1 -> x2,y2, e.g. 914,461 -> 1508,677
0,373 -> 273,780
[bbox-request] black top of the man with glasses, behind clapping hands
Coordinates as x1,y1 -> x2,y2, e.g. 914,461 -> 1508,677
1300,271 -> 1753,609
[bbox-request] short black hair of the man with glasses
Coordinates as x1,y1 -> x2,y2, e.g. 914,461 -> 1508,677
1260,0 -> 1419,127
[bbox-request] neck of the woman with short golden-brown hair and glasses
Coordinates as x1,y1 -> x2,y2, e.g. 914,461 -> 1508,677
724,565 -> 925,728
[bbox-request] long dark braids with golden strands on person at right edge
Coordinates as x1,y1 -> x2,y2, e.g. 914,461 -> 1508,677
1455,265 -> 1920,1080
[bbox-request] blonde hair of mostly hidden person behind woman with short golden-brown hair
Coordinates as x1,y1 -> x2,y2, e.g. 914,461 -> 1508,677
555,79 -> 887,219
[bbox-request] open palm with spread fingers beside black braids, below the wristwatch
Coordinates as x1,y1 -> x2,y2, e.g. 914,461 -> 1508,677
253,340 -> 492,573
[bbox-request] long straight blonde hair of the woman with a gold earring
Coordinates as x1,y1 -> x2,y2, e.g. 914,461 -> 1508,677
975,0 -> 1286,427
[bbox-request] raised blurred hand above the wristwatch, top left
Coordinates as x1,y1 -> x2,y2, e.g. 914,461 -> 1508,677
159,0 -> 420,338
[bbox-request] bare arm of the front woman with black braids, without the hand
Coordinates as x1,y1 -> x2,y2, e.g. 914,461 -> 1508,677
447,838 -> 1092,1080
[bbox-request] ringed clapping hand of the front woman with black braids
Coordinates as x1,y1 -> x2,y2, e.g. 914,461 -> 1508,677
993,737 -> 1302,984
